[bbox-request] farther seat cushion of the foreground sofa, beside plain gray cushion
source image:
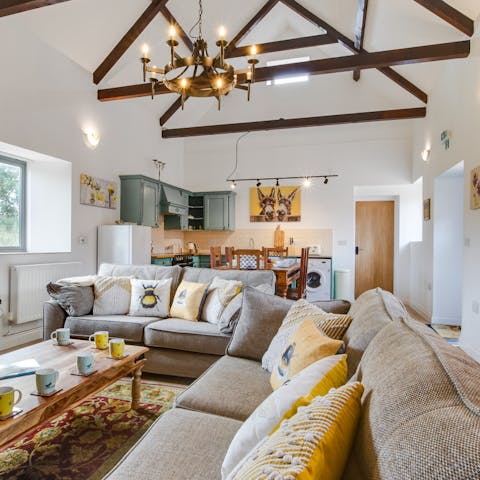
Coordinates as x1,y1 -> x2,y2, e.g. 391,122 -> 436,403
175,355 -> 272,420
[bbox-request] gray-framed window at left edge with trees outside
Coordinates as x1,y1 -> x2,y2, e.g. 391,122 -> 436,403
0,155 -> 26,251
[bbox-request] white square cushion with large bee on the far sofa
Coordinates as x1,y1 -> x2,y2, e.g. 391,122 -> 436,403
128,278 -> 172,318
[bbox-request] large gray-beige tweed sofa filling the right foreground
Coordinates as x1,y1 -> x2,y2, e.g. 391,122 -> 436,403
106,288 -> 480,480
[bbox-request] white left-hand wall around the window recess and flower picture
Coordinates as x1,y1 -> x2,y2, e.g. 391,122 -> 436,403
0,22 -> 183,348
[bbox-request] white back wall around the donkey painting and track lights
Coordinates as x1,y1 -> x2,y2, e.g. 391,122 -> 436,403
185,122 -> 411,300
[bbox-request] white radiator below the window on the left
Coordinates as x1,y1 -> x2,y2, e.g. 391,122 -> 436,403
10,262 -> 81,324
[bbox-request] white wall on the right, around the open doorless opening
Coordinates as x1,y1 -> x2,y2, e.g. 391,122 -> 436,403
411,33 -> 480,359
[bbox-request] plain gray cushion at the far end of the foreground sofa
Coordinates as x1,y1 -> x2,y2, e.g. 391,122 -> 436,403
227,287 -> 294,361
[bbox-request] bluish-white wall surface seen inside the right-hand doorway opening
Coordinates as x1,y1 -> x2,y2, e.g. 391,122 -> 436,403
432,172 -> 464,325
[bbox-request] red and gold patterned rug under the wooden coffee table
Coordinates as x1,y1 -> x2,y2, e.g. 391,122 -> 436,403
0,380 -> 184,480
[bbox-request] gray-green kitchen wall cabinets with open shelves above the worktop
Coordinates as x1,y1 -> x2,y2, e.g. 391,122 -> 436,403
120,175 -> 235,231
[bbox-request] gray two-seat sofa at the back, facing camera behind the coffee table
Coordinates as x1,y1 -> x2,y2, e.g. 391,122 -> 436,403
43,263 -> 350,378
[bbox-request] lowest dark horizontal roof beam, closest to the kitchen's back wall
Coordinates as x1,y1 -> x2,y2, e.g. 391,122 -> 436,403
162,107 -> 427,138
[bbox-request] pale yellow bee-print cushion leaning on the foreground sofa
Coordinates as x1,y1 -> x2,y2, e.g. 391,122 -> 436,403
270,320 -> 343,390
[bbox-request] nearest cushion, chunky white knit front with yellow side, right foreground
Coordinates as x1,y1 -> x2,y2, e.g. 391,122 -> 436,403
228,382 -> 363,480
